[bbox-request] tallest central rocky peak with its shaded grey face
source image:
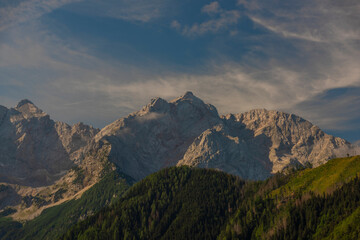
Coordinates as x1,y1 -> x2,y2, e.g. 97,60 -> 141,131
95,92 -> 221,180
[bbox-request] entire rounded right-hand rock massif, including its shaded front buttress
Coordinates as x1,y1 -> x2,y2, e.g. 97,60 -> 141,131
178,109 -> 351,179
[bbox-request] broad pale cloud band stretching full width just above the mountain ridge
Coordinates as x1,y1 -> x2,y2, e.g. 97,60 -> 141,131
0,21 -> 360,131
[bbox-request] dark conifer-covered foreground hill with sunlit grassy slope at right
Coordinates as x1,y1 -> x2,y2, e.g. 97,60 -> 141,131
61,157 -> 360,239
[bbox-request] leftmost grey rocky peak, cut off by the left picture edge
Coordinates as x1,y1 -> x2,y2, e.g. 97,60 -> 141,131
0,100 -> 98,186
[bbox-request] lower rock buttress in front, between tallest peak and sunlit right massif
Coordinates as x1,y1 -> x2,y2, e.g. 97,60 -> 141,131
177,123 -> 272,179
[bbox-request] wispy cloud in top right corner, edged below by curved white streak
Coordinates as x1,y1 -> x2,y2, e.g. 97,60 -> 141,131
238,0 -> 360,42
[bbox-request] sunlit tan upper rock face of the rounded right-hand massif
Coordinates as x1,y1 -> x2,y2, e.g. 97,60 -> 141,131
231,109 -> 351,173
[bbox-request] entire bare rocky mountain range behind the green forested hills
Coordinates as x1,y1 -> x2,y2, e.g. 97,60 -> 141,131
0,92 -> 352,225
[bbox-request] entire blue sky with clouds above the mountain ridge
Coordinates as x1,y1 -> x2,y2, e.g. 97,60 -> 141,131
0,0 -> 360,142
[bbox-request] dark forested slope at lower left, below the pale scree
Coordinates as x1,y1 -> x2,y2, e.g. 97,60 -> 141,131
0,172 -> 133,240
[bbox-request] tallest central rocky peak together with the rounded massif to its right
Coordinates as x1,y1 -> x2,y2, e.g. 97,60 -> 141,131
95,92 -> 351,180
